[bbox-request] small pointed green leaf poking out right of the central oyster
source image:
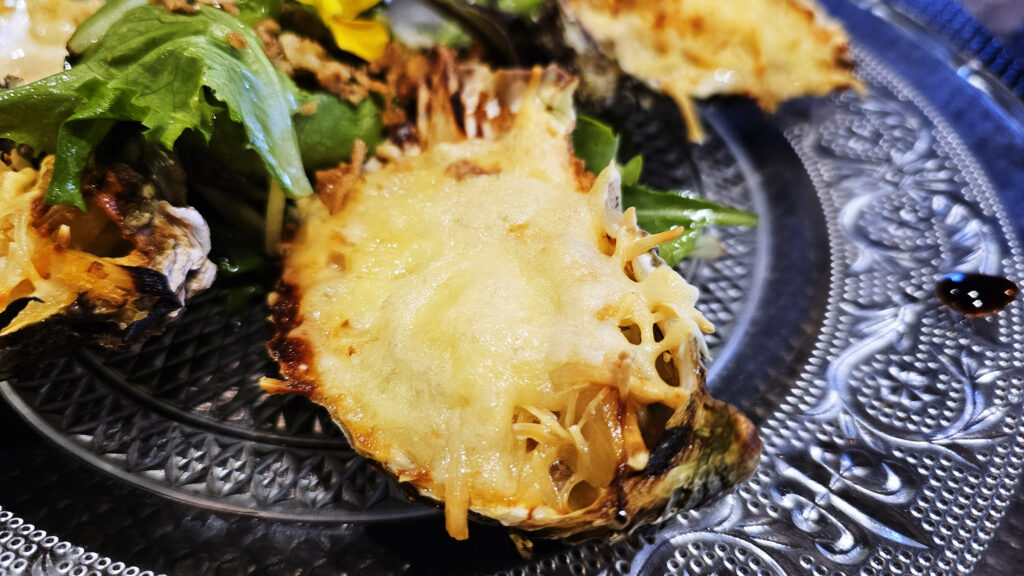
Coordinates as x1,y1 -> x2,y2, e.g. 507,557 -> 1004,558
572,115 -> 758,266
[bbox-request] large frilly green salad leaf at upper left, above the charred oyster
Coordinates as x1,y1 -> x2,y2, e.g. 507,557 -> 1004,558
0,0 -> 312,209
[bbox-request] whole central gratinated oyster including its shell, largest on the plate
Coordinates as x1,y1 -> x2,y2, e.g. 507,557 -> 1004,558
263,52 -> 760,539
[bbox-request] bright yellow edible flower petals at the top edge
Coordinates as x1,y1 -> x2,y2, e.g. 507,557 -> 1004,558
299,0 -> 389,61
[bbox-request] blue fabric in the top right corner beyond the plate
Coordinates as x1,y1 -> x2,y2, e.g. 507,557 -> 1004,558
889,0 -> 1024,97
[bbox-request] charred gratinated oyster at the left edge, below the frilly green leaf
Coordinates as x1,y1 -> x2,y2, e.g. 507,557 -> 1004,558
0,151 -> 216,371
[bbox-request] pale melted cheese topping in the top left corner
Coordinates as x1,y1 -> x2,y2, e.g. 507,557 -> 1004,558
0,0 -> 102,83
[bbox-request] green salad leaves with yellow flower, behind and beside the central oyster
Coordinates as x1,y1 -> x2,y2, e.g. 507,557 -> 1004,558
0,0 -> 757,265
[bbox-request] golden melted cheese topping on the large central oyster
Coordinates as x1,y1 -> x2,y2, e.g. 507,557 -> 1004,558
285,86 -> 711,538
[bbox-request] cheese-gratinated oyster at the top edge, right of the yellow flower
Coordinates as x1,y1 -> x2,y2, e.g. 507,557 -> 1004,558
559,0 -> 861,141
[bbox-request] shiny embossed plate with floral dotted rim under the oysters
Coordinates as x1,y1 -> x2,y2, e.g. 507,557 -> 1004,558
0,0 -> 1024,576
